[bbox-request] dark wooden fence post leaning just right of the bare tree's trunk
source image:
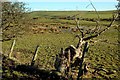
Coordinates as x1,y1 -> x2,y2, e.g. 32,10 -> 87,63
77,42 -> 88,80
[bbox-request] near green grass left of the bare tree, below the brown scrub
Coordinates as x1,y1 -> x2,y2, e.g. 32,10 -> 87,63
3,33 -> 76,69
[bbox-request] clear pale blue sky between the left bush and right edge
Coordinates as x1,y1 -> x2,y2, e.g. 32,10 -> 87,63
27,2 -> 117,11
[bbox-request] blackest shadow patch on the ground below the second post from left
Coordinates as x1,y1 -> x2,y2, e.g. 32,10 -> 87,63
14,65 -> 66,80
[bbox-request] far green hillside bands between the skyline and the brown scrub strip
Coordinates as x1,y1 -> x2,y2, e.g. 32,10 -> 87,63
28,11 -> 115,27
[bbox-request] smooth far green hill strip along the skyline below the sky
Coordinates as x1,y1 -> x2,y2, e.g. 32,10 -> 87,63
29,11 -> 115,18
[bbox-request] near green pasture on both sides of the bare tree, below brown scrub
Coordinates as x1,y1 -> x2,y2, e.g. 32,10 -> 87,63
3,25 -> 120,78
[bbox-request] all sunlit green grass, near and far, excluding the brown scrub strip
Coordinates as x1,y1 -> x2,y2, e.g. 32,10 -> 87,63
2,11 -> 120,79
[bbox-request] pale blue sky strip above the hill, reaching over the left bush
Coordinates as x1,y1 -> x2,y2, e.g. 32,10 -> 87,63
7,0 -> 118,11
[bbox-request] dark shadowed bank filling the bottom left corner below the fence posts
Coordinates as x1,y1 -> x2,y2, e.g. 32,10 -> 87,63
2,56 -> 67,80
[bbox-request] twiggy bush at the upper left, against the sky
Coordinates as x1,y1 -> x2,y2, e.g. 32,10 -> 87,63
1,2 -> 28,40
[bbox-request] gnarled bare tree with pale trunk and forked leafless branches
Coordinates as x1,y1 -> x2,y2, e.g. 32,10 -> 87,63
56,2 -> 118,80
